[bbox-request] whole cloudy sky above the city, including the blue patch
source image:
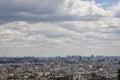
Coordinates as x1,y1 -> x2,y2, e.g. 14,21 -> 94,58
0,0 -> 120,57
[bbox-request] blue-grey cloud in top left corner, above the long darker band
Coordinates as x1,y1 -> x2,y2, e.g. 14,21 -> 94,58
0,0 -> 63,15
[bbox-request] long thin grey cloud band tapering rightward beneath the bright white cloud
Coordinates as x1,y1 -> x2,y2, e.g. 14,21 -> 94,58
0,14 -> 101,23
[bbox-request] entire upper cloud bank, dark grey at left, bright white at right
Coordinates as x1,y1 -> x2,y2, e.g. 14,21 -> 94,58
0,0 -> 119,23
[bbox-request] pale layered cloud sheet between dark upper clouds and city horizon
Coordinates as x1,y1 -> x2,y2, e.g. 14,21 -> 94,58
0,18 -> 120,55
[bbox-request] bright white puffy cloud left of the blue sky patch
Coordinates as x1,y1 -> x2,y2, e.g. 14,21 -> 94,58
62,0 -> 107,16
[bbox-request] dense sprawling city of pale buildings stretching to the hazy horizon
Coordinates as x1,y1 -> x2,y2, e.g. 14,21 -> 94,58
0,55 -> 120,80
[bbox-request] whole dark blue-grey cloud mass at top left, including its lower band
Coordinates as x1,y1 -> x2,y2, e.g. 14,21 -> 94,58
0,0 -> 63,23
